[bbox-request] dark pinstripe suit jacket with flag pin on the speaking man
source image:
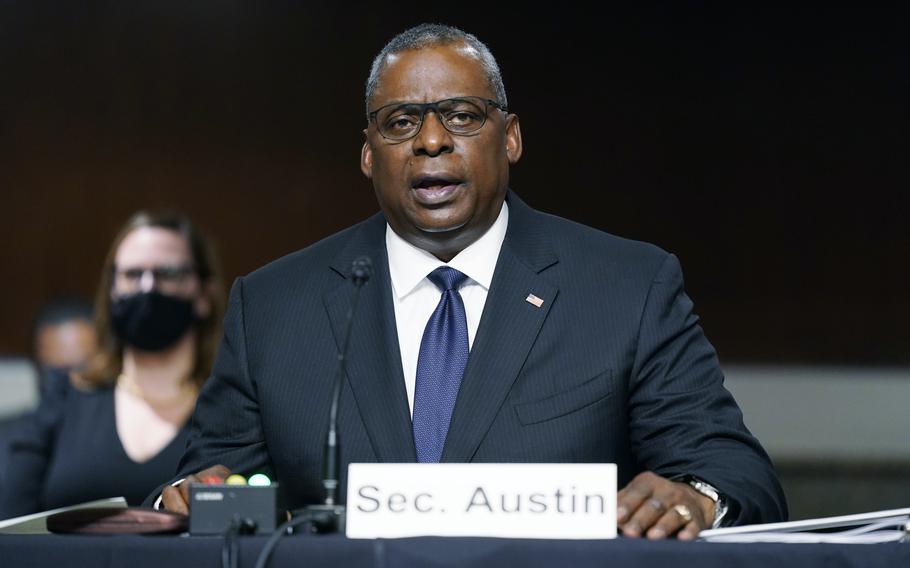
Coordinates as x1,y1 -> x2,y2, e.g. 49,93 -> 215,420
166,192 -> 786,522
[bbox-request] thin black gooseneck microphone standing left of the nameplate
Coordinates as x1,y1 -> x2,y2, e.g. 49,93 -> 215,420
301,256 -> 373,533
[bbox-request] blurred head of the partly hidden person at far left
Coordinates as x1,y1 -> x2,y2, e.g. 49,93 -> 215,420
32,298 -> 98,386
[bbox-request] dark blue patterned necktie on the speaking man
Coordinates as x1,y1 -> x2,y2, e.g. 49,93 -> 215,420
412,266 -> 468,463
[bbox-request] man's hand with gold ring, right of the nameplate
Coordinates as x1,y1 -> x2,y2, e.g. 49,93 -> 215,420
616,471 -> 714,540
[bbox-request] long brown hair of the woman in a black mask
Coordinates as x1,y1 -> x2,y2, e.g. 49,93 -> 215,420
80,211 -> 225,387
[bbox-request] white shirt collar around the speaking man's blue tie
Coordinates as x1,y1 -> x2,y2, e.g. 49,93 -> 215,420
385,201 -> 509,299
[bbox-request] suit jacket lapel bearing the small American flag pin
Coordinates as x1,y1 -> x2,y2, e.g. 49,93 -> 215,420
442,192 -> 559,462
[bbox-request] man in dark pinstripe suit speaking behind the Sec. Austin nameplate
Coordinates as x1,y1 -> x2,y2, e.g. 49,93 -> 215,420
155,26 -> 786,538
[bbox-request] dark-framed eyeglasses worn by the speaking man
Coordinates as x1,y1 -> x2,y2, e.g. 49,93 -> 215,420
368,97 -> 508,142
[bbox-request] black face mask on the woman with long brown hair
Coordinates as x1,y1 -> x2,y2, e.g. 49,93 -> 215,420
111,290 -> 195,351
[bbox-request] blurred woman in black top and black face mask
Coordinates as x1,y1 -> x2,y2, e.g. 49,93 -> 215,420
0,213 -> 224,518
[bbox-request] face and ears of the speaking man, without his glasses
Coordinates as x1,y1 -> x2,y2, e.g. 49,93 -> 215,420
361,44 -> 521,261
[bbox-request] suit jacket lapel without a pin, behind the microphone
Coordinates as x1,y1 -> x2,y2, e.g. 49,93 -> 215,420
323,215 -> 416,462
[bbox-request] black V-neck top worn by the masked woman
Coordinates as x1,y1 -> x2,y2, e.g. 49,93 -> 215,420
0,381 -> 188,518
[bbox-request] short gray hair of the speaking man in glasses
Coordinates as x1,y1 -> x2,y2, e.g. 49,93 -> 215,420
365,24 -> 509,115
